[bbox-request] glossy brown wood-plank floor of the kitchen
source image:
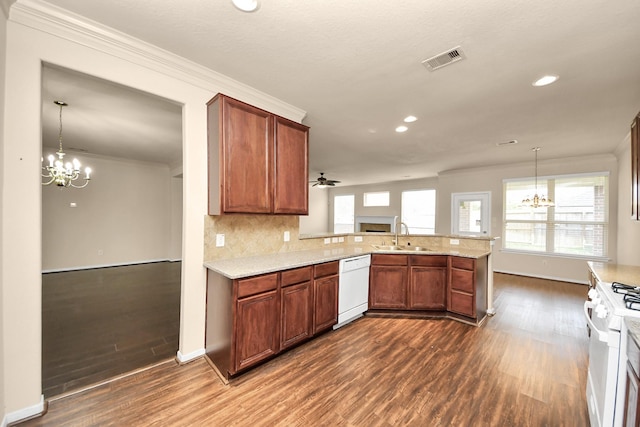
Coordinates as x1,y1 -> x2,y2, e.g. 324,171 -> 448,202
22,274 -> 589,427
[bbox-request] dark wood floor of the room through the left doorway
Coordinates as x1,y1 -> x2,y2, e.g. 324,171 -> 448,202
42,262 -> 181,398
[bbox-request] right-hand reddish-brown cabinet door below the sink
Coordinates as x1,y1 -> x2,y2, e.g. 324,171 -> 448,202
409,267 -> 447,310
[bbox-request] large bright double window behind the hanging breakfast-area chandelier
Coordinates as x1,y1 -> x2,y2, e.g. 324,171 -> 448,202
504,173 -> 609,257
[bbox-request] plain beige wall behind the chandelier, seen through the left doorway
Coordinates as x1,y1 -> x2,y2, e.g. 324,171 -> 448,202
42,155 -> 175,271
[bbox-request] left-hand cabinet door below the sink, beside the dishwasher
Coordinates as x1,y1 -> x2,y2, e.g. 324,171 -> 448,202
369,265 -> 408,309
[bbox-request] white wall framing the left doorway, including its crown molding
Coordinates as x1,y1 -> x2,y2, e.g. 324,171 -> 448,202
0,1 -> 304,417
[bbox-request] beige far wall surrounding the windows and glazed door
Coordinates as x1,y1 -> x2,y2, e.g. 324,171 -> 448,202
329,155 -> 616,283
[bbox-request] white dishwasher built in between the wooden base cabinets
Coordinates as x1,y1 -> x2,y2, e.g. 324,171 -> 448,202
333,254 -> 371,329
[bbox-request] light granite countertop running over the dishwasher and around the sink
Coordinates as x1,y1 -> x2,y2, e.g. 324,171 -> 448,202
204,244 -> 490,279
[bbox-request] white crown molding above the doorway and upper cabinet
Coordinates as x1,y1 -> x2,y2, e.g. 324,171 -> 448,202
7,0 -> 306,122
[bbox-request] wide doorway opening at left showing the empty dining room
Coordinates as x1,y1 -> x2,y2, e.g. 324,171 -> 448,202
42,64 -> 183,398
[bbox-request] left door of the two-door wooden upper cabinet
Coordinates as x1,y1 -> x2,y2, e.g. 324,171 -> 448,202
220,97 -> 273,213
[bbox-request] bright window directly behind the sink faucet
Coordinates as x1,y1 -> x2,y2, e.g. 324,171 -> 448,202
401,190 -> 436,234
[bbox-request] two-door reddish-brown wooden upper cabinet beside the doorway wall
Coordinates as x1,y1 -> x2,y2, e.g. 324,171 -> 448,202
207,94 -> 309,215
